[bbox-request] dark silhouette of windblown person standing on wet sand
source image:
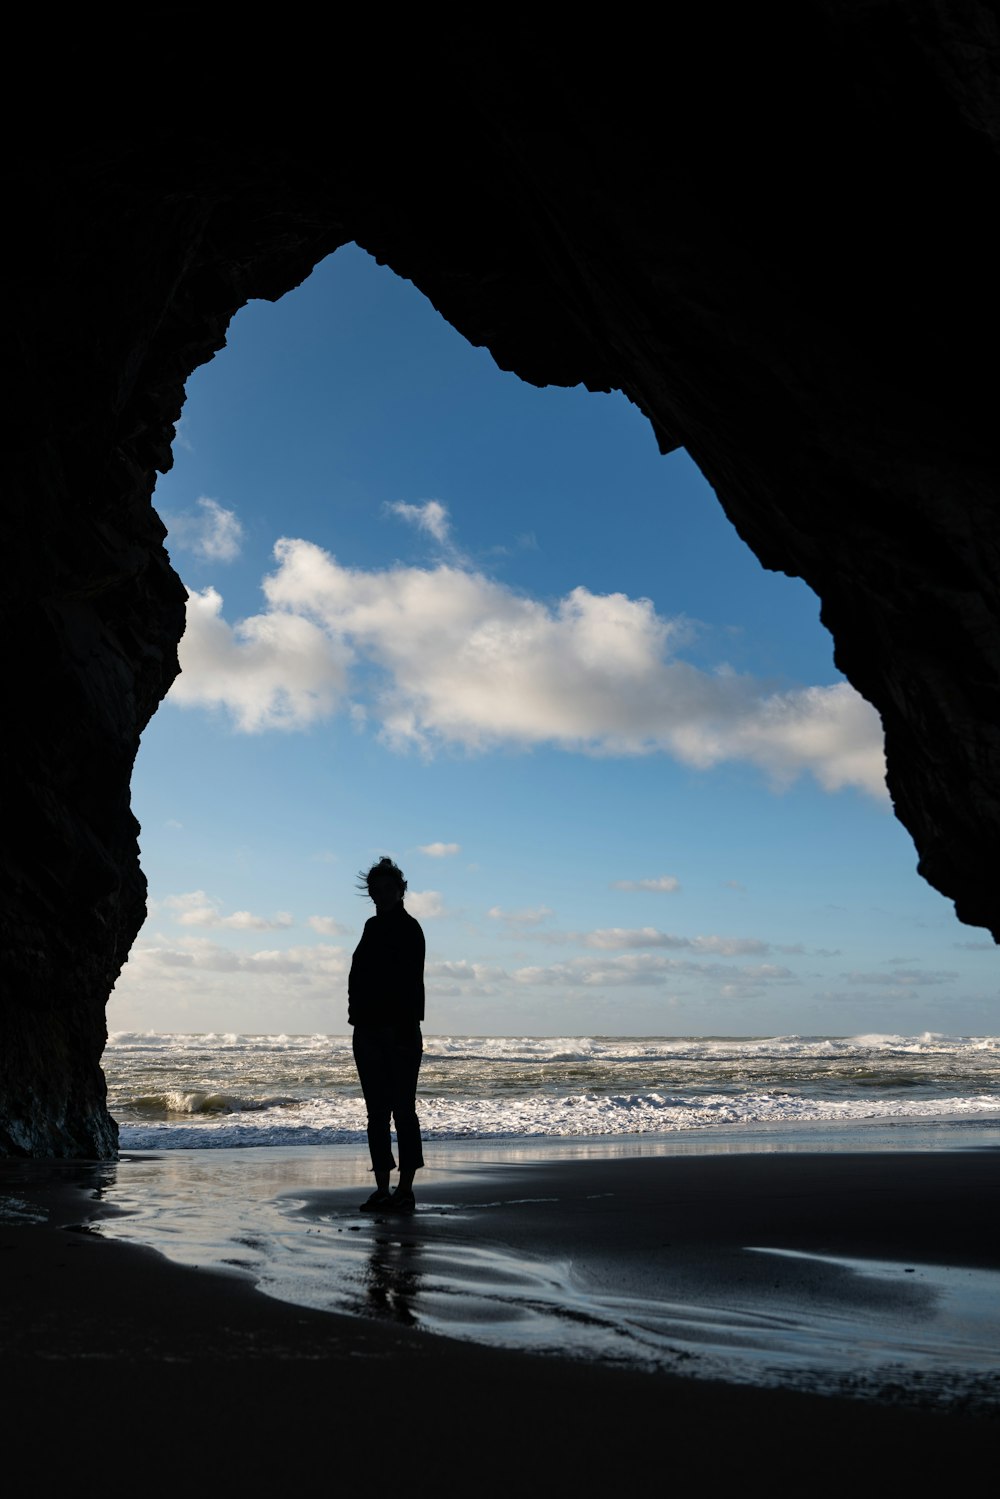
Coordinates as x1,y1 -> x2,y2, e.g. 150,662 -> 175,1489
348,859 -> 426,1213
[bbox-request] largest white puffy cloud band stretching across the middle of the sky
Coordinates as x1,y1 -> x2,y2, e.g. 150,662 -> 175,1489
171,536 -> 886,797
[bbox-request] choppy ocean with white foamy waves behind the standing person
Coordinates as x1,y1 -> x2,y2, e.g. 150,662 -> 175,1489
103,1031 -> 1000,1151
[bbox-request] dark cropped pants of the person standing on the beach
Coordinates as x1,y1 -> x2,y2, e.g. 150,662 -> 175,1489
354,1022 -> 424,1174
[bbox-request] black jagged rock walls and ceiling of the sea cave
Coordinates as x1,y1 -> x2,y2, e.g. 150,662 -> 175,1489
0,0 -> 1000,1157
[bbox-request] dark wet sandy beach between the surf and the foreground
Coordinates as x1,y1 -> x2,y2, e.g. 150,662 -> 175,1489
0,1148 -> 1000,1495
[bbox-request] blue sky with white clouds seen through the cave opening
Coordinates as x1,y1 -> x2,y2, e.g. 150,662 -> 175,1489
108,246 -> 997,1036
